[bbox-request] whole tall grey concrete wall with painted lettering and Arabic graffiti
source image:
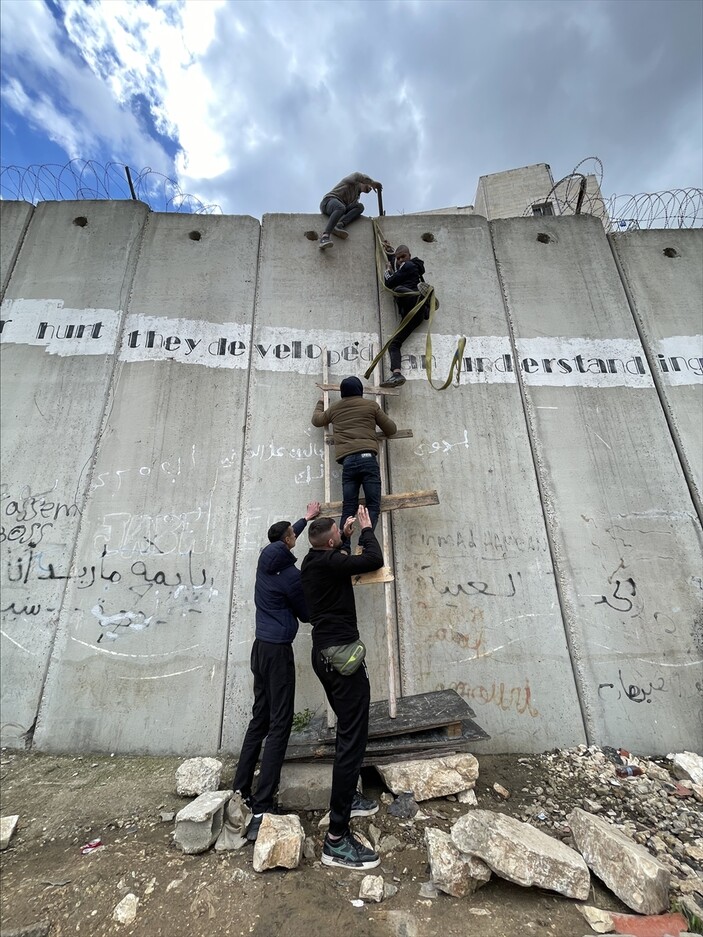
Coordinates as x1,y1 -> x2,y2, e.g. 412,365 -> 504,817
0,202 -> 703,754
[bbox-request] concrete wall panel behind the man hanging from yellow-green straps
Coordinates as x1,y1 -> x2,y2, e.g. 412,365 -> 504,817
381,216 -> 585,752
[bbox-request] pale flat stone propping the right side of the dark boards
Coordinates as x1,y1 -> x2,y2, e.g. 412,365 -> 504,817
376,754 -> 478,801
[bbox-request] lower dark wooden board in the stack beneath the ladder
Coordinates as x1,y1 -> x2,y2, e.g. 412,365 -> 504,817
285,720 -> 490,765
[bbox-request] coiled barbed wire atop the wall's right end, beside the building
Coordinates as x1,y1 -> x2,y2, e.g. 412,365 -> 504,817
523,156 -> 703,234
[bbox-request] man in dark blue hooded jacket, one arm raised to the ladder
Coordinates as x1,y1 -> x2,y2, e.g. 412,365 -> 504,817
232,501 -> 320,842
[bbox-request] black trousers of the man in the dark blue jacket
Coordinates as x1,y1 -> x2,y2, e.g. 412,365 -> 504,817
232,638 -> 295,813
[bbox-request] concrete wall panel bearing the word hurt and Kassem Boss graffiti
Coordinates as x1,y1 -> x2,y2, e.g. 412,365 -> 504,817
0,202 -> 147,745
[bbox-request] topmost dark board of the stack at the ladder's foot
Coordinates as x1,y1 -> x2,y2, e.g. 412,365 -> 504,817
320,690 -> 476,741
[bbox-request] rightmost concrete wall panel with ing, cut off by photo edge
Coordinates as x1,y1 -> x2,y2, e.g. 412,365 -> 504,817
609,228 -> 703,516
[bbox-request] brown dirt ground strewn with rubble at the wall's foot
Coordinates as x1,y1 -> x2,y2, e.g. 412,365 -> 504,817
0,748 -> 703,937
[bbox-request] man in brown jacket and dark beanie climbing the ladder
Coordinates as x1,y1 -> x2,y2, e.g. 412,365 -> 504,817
312,377 -> 398,530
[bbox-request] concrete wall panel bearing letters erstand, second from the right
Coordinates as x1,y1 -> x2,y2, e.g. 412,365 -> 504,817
491,217 -> 703,753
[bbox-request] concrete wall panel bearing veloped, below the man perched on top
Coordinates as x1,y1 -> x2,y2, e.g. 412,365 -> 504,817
223,215 -> 388,750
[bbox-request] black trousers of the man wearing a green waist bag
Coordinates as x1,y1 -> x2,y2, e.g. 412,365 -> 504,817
312,648 -> 371,836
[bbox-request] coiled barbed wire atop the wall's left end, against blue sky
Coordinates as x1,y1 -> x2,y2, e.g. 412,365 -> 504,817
0,159 -> 222,215
